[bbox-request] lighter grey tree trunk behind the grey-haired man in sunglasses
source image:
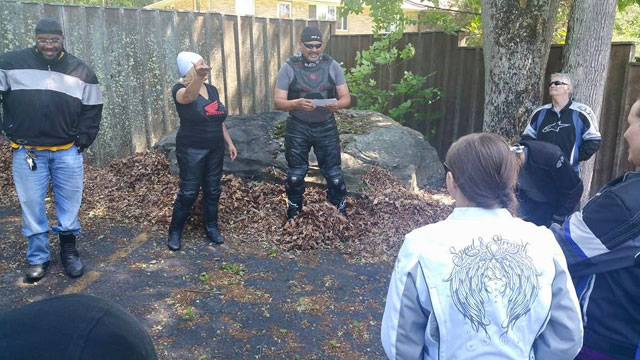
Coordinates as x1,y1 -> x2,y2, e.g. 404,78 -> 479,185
562,0 -> 618,203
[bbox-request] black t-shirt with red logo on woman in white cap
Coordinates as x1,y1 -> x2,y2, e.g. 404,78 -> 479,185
171,83 -> 227,149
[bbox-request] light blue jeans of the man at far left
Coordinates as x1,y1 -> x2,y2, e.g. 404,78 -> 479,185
13,146 -> 83,265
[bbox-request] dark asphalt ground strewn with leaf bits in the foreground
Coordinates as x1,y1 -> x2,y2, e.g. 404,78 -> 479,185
0,206 -> 392,359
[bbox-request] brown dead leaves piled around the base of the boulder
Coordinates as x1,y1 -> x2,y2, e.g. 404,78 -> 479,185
0,151 -> 451,257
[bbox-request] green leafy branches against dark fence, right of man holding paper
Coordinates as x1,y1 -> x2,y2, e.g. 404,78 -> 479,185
342,0 -> 440,123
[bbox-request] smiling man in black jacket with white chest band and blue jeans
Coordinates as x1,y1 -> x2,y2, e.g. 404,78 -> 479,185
0,18 -> 102,281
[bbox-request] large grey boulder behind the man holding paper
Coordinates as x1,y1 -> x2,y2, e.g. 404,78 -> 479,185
154,110 -> 444,192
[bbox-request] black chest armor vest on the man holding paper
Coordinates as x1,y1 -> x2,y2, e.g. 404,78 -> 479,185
287,55 -> 336,100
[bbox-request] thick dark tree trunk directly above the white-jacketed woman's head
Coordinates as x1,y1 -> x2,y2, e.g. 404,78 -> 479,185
482,0 -> 560,139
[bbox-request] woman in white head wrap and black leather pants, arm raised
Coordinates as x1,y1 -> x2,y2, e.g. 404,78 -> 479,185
167,51 -> 238,251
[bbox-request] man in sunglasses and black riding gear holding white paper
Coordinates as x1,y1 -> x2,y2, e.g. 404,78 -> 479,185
273,27 -> 351,219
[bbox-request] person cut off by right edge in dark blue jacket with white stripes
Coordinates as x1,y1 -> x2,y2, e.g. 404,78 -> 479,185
551,99 -> 640,360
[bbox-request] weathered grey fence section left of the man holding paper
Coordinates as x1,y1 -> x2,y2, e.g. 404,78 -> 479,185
0,1 -> 334,165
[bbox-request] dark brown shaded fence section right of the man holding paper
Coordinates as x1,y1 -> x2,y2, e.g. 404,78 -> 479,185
327,32 -> 640,191
